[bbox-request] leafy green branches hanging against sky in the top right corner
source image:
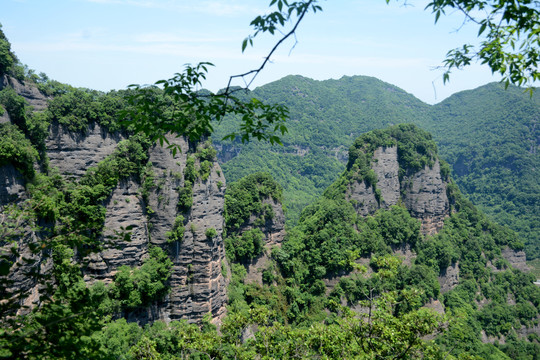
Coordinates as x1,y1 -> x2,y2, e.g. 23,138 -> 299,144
426,0 -> 540,92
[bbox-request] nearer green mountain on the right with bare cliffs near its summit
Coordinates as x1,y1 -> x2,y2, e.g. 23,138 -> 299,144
226,124 -> 540,359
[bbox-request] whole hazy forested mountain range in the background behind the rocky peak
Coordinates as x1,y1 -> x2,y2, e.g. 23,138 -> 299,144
213,76 -> 540,259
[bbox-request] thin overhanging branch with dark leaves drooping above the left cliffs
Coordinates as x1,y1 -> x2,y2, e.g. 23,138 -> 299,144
121,0 -> 322,149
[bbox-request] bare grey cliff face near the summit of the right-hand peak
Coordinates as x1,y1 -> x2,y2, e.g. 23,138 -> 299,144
346,146 -> 450,234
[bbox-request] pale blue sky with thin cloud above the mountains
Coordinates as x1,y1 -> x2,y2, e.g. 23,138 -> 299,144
0,0 -> 508,104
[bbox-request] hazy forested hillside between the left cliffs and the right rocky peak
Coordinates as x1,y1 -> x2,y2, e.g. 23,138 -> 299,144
212,76 -> 429,224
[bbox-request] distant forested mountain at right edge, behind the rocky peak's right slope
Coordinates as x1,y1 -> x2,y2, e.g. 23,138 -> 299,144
422,83 -> 540,259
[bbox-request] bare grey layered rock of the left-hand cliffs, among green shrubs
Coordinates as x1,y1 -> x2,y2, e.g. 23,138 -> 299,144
0,77 -> 228,322
